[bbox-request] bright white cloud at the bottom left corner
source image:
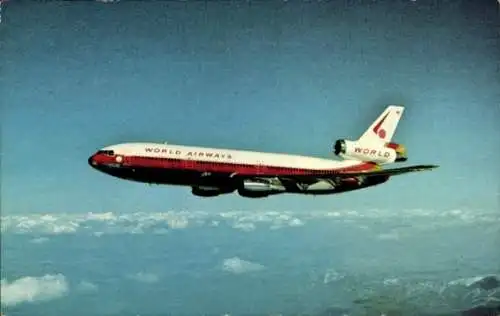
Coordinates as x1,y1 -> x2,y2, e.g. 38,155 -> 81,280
0,274 -> 69,306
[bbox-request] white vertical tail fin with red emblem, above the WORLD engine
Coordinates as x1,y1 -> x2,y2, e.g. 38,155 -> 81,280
358,105 -> 404,145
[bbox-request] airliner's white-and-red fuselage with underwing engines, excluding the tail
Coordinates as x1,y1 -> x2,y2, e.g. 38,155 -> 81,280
89,143 -> 385,197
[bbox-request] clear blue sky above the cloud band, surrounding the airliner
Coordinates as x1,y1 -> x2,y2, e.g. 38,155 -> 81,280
0,1 -> 500,213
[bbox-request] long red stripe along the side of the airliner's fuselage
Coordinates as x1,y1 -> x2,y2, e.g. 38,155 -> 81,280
119,156 -> 375,175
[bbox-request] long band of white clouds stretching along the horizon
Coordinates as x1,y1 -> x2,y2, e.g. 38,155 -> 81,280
1,209 -> 500,236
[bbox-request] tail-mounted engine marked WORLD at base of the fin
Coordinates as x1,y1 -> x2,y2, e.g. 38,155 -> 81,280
333,139 -> 407,164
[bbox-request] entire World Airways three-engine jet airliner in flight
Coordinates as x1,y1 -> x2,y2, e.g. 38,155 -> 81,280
88,105 -> 438,198
